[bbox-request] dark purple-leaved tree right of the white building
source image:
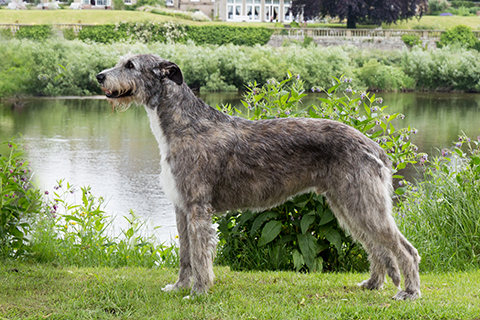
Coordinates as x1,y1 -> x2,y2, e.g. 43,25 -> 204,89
292,0 -> 428,28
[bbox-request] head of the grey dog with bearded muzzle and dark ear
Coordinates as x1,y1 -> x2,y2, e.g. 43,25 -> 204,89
97,54 -> 183,107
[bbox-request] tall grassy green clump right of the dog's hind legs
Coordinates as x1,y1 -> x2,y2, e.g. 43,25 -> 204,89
396,135 -> 480,271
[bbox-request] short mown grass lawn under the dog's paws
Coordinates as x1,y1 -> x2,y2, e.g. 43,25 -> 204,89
0,261 -> 480,319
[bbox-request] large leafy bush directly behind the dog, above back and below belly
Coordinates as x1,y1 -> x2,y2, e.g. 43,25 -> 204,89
216,73 -> 416,272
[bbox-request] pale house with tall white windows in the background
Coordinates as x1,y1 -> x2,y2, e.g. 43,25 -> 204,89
173,0 -> 293,23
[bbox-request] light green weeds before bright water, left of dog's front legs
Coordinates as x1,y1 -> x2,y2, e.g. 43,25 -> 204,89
32,180 -> 178,267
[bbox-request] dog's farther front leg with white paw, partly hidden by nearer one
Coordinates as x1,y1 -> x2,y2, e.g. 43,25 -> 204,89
162,207 -> 192,291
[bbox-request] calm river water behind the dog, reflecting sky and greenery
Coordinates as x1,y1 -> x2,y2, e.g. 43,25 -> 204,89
0,93 -> 480,241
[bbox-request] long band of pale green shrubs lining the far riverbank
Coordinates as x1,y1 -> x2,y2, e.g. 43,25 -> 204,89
0,40 -> 480,97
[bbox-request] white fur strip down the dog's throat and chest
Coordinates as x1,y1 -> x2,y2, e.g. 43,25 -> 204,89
145,107 -> 181,206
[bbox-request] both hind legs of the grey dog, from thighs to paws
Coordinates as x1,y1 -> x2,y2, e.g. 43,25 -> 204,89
326,189 -> 420,300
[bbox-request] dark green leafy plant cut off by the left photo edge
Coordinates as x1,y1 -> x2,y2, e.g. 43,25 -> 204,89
0,140 -> 42,257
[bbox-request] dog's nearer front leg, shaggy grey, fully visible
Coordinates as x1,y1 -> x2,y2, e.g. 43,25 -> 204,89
188,205 -> 217,295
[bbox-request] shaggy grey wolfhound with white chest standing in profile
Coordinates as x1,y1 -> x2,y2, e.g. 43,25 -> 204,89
97,54 -> 420,300
